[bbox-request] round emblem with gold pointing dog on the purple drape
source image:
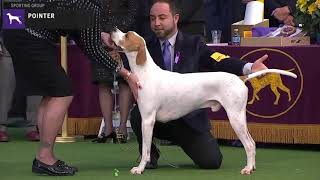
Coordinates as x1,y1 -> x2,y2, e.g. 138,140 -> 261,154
241,48 -> 303,119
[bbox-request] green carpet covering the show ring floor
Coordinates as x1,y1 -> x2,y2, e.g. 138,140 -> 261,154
0,128 -> 320,180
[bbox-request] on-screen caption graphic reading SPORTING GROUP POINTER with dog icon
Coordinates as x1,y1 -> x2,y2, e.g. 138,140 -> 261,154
0,0 -> 94,29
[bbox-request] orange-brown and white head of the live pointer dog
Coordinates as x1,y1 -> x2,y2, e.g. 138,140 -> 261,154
111,29 -> 147,65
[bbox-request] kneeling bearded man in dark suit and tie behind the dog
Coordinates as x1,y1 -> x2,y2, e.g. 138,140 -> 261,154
130,0 -> 267,169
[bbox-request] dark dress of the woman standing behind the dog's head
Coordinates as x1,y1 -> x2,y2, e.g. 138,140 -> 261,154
91,0 -> 138,86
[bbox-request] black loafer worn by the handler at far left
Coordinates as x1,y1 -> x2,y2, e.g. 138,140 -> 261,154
32,159 -> 75,176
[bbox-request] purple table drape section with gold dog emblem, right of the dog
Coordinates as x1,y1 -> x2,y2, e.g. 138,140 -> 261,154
209,45 -> 320,124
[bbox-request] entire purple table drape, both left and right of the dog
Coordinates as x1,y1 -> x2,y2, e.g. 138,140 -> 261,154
64,46 -> 320,124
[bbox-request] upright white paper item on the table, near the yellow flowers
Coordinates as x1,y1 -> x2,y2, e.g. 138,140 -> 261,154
244,1 -> 264,25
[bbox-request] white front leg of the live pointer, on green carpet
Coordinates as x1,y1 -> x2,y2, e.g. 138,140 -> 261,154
131,112 -> 156,174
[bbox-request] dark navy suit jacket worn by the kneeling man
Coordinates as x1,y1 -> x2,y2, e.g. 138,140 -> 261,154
146,32 -> 246,132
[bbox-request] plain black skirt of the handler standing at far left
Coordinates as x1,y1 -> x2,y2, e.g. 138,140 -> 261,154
5,30 -> 72,97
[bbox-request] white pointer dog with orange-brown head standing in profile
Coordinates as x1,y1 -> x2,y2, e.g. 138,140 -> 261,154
111,29 -> 297,174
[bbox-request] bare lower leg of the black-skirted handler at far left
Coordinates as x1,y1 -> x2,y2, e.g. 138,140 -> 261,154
36,96 -> 73,165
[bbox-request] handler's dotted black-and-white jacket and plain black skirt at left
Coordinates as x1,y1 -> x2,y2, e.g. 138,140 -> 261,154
4,0 -> 122,97
